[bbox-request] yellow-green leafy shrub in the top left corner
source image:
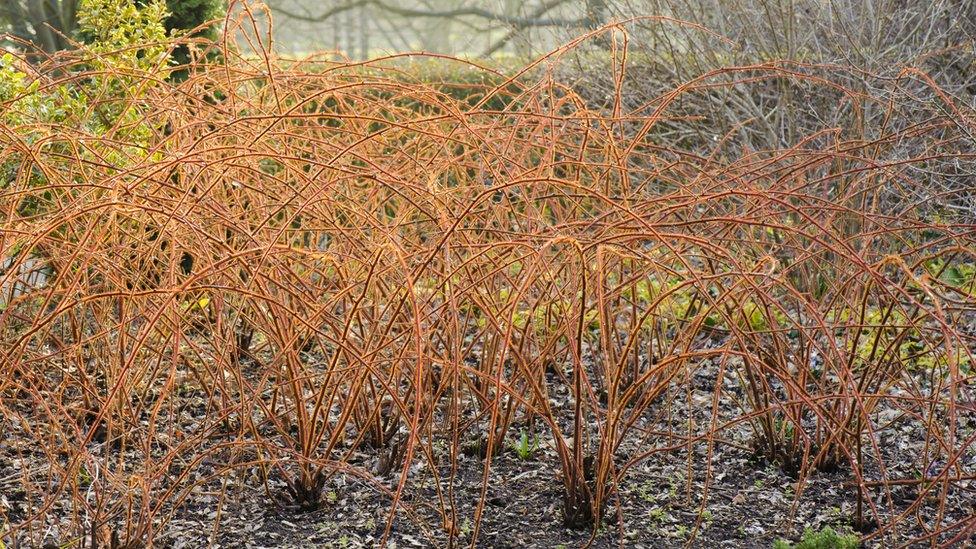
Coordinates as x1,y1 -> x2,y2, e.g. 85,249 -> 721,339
0,0 -> 169,201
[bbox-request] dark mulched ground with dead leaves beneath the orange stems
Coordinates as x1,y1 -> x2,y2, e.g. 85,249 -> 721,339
0,348 -> 976,548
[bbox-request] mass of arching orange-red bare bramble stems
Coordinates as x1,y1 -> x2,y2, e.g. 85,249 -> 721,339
0,0 -> 976,546
